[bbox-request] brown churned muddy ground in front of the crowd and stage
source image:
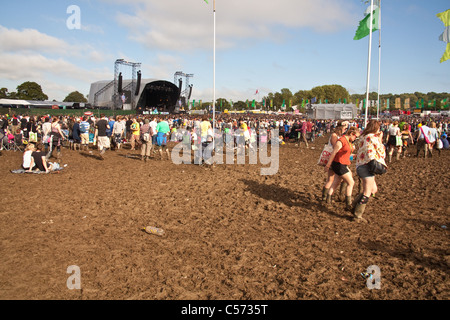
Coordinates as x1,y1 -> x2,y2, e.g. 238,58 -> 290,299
0,139 -> 450,300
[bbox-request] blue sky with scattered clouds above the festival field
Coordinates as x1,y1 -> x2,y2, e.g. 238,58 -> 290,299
0,0 -> 450,101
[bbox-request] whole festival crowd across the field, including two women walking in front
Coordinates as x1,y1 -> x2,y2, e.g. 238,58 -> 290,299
0,114 -> 450,222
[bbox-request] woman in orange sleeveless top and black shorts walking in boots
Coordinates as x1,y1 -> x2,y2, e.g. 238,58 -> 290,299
325,127 -> 359,210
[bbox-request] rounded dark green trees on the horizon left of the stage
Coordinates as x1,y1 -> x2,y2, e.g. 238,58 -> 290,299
0,81 -> 88,103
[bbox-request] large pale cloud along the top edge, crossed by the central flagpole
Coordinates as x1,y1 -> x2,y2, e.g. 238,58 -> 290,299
110,0 -> 357,51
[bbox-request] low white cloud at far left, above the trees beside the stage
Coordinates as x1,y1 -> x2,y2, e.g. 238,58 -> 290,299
0,26 -> 111,99
